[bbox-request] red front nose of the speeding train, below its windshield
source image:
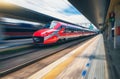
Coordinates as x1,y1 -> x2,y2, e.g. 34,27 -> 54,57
33,29 -> 59,44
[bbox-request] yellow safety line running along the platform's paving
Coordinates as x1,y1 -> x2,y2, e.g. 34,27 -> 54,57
41,37 -> 96,79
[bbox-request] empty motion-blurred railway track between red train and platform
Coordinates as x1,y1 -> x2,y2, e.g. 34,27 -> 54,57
0,37 -> 94,77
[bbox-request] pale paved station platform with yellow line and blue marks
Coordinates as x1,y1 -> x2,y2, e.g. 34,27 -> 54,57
28,34 -> 109,79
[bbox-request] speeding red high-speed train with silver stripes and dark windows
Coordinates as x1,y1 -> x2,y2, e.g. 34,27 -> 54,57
33,21 -> 95,44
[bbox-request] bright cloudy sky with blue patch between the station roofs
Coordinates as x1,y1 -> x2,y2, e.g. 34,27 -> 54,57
2,0 -> 97,29
